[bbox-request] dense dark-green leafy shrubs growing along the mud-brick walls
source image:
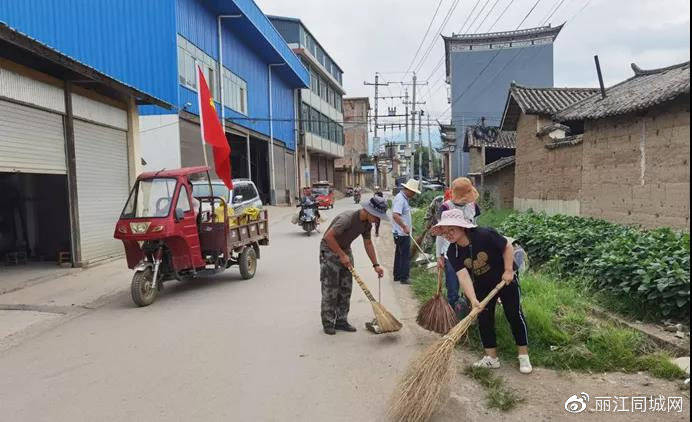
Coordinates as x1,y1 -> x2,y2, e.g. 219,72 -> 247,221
500,212 -> 690,320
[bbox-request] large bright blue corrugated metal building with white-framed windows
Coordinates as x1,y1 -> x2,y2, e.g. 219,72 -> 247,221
0,0 -> 310,202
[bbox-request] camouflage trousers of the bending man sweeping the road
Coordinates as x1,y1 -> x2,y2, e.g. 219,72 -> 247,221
320,250 -> 353,327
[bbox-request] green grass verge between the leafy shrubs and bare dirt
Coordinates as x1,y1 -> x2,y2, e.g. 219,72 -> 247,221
411,269 -> 685,380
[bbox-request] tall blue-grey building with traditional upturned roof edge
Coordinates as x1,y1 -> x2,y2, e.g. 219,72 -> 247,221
443,25 -> 562,178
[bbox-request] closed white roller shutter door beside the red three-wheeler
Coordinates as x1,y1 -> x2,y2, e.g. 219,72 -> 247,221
74,120 -> 129,264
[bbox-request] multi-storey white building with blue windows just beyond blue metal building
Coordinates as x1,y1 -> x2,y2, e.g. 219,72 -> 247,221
269,16 -> 345,185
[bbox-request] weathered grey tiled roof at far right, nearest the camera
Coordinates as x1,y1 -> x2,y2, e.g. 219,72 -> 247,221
555,61 -> 690,122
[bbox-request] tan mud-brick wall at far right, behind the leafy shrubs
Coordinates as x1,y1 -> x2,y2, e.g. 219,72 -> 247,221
581,97 -> 690,230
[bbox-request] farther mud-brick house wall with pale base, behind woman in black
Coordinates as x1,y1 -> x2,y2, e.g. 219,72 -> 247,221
514,114 -> 582,215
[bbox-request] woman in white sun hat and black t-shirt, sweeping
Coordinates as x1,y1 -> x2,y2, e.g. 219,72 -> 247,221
431,209 -> 532,374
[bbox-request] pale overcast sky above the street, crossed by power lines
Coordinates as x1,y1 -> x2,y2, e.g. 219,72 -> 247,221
255,0 -> 690,148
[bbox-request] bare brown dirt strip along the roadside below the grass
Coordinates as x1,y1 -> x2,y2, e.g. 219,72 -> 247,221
377,230 -> 690,421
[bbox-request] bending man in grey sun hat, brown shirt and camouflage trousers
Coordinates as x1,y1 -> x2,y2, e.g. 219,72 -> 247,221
320,196 -> 388,335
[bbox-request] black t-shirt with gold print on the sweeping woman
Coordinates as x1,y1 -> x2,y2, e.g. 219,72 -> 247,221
447,227 -> 507,285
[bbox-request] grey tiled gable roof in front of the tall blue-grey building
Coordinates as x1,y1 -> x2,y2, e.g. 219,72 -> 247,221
500,83 -> 599,130
